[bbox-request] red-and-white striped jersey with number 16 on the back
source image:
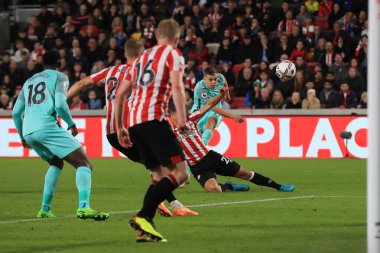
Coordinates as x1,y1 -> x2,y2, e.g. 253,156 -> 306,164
127,45 -> 185,127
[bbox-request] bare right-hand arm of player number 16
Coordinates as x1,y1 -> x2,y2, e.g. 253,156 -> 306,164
170,71 -> 190,134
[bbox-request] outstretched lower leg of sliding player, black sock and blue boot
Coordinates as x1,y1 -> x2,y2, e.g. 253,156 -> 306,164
235,167 -> 296,192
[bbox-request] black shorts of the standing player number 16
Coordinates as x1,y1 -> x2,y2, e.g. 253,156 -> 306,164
129,120 -> 185,169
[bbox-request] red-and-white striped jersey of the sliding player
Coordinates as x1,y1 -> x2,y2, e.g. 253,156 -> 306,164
170,111 -> 209,166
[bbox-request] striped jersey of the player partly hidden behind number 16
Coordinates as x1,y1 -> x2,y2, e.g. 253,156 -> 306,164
90,64 -> 131,135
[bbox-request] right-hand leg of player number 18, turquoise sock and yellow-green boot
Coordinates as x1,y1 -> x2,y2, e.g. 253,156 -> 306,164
64,147 -> 109,220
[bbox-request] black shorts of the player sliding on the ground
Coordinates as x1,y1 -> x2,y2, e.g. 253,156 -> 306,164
190,150 -> 240,188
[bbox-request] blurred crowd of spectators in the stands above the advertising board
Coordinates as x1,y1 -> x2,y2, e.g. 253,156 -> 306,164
0,0 -> 368,110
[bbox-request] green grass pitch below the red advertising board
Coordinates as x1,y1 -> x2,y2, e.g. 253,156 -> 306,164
0,159 -> 366,253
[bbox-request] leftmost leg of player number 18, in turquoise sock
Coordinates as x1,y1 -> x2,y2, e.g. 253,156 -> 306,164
37,156 -> 63,218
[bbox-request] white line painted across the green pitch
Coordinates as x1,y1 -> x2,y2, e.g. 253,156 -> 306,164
0,195 -> 366,225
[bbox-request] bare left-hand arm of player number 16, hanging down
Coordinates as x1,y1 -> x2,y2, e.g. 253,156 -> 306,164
115,80 -> 132,148
